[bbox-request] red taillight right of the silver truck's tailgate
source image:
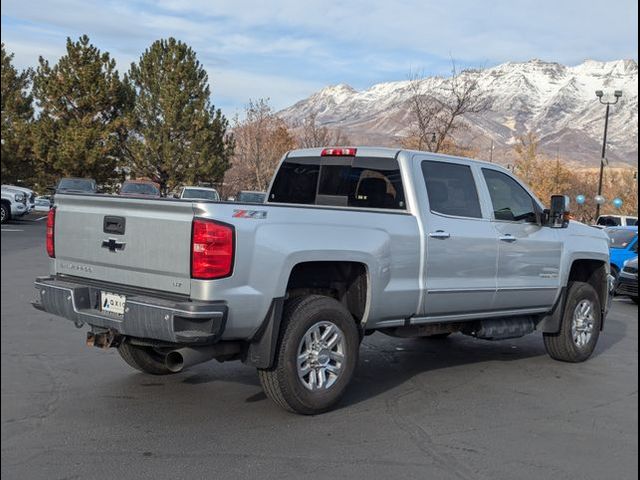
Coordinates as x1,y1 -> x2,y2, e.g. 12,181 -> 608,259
191,218 -> 235,280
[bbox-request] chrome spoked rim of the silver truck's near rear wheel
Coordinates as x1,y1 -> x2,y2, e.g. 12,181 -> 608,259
296,322 -> 346,391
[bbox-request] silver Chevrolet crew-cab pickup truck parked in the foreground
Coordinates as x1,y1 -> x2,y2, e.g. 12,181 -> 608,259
34,147 -> 612,414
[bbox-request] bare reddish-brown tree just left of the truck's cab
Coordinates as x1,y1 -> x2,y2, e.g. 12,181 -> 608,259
225,98 -> 296,191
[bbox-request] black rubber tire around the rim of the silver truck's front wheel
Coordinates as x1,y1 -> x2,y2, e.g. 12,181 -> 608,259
543,282 -> 602,363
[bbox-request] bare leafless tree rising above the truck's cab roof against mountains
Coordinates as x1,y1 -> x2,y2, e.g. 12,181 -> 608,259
405,60 -> 489,152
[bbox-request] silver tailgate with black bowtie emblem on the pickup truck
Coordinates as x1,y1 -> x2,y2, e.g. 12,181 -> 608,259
54,195 -> 193,295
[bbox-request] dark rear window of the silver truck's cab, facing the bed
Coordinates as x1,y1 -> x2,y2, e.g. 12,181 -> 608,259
269,157 -> 406,210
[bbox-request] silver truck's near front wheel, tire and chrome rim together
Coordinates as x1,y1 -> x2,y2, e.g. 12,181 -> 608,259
544,282 -> 602,363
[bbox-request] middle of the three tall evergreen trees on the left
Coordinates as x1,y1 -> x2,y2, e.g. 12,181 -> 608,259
33,35 -> 133,185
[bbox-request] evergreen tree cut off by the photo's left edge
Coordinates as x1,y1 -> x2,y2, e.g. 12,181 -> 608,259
0,43 -> 33,184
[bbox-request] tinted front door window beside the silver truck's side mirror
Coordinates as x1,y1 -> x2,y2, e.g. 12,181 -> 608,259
482,168 -> 537,223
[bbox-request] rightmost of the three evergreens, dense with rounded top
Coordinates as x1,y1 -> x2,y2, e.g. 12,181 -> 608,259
128,38 -> 234,191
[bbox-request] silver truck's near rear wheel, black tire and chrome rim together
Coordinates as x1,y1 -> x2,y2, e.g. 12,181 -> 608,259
258,295 -> 360,415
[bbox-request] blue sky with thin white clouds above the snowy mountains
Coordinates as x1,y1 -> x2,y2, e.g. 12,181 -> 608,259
2,0 -> 638,116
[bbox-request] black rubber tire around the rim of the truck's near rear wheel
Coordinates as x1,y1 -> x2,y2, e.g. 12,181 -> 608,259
258,295 -> 360,415
